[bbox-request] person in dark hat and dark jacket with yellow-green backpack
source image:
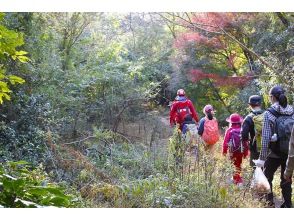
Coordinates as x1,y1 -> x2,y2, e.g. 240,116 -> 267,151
241,95 -> 264,167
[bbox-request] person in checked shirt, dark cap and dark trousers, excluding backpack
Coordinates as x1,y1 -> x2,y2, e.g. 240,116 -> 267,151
254,86 -> 294,208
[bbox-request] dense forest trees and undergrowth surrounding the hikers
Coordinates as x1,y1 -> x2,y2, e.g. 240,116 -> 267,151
0,12 -> 294,207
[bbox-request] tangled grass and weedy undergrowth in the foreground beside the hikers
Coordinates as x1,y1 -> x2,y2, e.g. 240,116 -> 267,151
46,130 -> 264,207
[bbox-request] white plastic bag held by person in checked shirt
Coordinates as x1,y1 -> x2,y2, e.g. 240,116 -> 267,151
251,167 -> 271,193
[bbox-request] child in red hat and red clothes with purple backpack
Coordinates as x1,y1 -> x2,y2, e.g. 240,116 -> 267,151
223,113 -> 248,186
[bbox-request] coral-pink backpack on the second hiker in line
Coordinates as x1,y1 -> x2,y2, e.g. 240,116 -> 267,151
202,118 -> 219,145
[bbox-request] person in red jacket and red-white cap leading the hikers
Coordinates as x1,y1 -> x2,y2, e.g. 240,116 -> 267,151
170,89 -> 199,130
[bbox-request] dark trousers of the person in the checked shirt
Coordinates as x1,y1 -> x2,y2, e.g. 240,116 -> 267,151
264,157 -> 292,208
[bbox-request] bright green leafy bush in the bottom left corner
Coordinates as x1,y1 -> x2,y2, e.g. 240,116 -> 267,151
0,161 -> 73,208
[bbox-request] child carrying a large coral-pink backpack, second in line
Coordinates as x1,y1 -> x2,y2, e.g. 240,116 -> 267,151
198,105 -> 219,152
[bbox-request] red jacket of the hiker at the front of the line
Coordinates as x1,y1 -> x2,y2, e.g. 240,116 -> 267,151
170,98 -> 199,126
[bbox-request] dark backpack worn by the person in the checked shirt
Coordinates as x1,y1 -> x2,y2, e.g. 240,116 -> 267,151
268,107 -> 294,156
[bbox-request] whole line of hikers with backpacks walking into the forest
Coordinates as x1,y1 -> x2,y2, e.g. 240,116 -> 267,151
170,86 -> 294,208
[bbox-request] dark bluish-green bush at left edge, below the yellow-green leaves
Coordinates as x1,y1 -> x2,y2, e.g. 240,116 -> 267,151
0,92 -> 51,165
